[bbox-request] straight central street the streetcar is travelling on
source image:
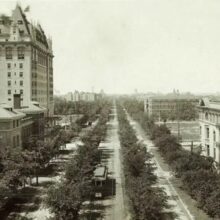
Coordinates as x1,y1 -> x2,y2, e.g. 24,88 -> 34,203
81,108 -> 130,220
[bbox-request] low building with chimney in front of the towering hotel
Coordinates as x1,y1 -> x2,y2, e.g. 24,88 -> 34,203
0,94 -> 47,147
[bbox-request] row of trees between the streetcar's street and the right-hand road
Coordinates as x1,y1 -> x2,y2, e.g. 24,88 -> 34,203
117,104 -> 173,220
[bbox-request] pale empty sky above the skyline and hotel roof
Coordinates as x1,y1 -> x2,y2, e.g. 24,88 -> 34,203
0,0 -> 220,93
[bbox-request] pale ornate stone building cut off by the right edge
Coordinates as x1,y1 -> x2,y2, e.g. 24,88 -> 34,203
198,98 -> 220,163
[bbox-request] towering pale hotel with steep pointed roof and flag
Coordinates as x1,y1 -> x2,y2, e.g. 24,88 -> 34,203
0,5 -> 54,116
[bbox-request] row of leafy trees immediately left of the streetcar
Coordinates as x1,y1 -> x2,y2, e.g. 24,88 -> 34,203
46,100 -> 111,220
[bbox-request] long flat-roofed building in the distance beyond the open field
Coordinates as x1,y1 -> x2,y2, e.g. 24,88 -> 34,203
144,95 -> 198,120
